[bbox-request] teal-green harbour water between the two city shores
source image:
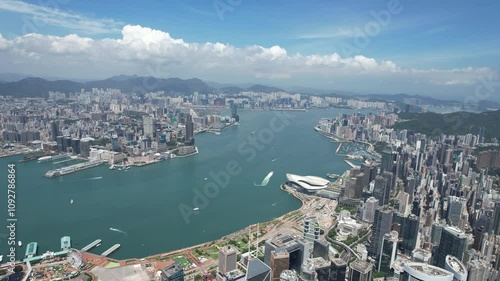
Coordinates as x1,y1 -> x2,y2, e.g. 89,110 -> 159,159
0,109 -> 372,259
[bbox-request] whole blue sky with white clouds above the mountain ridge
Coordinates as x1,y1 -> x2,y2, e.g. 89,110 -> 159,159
0,0 -> 500,100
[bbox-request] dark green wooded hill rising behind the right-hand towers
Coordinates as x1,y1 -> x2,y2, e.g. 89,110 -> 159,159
393,110 -> 500,141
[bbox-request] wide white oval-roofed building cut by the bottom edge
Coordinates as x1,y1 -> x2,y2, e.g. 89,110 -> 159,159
403,262 -> 453,281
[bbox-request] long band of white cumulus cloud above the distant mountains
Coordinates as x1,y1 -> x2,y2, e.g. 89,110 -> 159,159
0,25 -> 495,99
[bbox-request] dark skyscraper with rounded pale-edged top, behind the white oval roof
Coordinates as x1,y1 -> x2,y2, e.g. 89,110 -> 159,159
436,226 -> 467,268
